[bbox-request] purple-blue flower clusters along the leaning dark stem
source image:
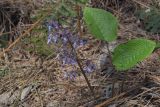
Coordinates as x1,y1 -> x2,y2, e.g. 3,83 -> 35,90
47,20 -> 96,79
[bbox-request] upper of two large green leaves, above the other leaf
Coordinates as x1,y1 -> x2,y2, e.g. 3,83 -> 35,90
84,7 -> 118,42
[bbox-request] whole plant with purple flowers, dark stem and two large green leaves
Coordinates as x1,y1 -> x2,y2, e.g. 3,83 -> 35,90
45,0 -> 156,97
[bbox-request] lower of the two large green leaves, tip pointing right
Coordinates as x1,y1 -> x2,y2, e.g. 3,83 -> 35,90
112,39 -> 156,71
